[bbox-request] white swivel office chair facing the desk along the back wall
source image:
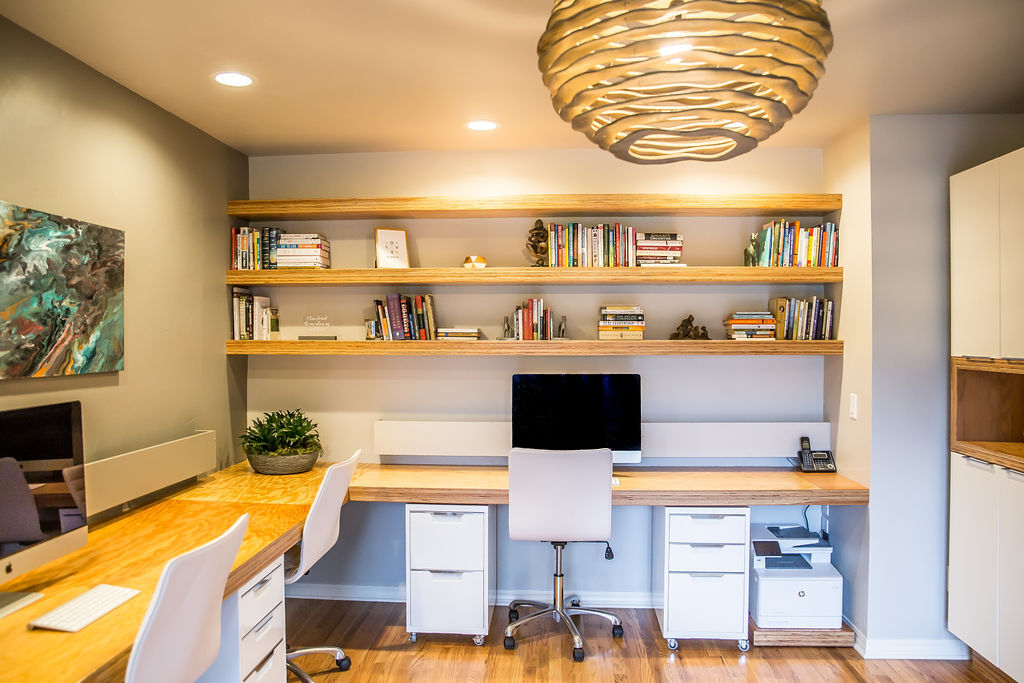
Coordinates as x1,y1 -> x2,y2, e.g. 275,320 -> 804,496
505,449 -> 623,661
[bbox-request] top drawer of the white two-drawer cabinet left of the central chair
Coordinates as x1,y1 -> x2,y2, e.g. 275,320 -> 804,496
409,509 -> 484,571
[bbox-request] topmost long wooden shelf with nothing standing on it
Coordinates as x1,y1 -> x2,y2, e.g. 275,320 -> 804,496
227,195 -> 843,220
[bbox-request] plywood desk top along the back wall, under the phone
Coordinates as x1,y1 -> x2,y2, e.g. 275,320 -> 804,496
348,464 -> 868,506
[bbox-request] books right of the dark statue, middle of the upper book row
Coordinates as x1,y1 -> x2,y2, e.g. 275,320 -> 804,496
548,223 -> 683,268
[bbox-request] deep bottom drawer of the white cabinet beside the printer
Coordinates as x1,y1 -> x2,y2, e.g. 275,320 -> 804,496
666,571 -> 746,638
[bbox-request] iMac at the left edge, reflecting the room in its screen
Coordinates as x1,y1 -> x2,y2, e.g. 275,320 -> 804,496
0,400 -> 87,616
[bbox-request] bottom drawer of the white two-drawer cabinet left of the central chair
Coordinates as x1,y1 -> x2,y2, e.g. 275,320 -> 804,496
407,571 -> 487,635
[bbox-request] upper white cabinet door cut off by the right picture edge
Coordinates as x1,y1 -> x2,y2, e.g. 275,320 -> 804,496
998,148 -> 1024,358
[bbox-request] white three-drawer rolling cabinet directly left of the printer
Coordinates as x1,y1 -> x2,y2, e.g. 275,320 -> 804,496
651,507 -> 751,651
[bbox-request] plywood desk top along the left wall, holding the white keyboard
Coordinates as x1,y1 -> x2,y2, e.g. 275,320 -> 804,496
0,463 -> 326,681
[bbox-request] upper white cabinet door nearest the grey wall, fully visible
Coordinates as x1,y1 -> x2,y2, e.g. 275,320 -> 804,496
949,160 -> 999,357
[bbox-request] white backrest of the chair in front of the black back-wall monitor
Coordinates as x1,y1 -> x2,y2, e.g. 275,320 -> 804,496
509,449 -> 611,541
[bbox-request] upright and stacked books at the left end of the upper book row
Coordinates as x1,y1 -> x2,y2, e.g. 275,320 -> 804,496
230,226 -> 331,270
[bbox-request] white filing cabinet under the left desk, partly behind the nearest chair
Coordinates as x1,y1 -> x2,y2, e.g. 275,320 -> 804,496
200,557 -> 288,683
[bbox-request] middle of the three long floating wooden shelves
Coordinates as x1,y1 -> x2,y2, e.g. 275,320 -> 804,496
225,266 -> 843,287
